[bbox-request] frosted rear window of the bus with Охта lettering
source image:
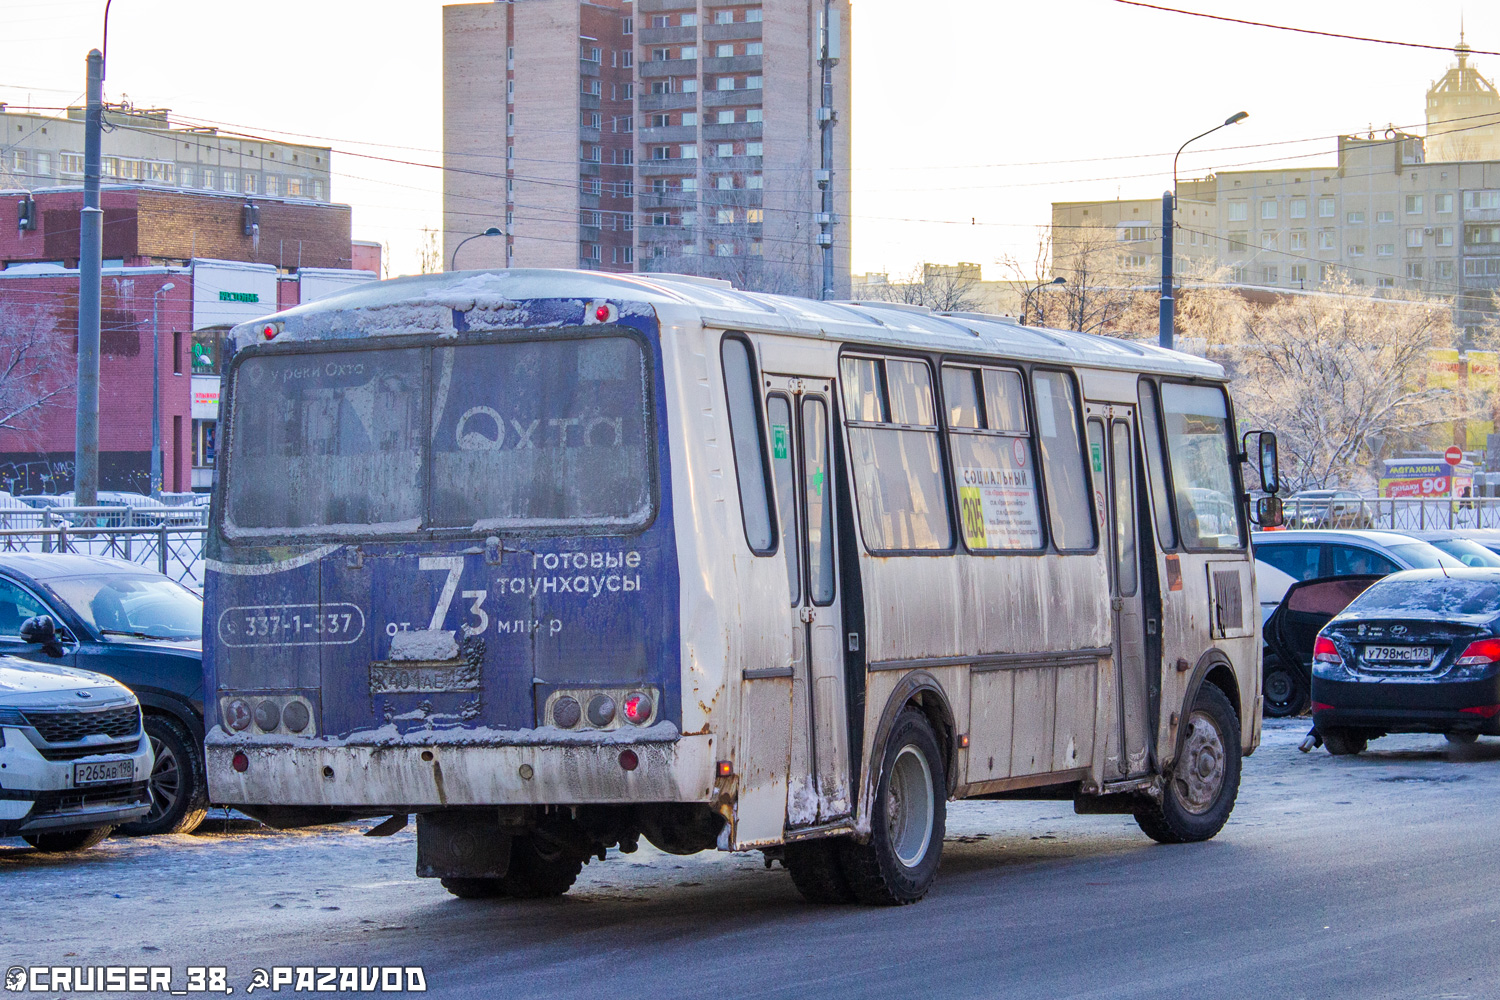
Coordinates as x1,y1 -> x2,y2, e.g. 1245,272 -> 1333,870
227,336 -> 653,535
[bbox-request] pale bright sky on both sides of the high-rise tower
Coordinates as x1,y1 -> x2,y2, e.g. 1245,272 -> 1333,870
0,0 -> 1500,279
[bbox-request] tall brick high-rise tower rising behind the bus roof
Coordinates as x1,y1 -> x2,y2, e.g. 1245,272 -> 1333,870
444,0 -> 851,295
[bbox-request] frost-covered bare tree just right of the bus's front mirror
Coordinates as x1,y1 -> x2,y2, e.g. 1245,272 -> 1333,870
1229,277 -> 1476,489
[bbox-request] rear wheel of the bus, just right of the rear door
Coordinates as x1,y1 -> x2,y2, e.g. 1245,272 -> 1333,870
839,708 -> 948,906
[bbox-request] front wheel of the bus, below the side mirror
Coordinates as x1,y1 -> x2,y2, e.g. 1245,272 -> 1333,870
1136,682 -> 1241,844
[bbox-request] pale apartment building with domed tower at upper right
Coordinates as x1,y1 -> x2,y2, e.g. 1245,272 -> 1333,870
1053,40 -> 1500,335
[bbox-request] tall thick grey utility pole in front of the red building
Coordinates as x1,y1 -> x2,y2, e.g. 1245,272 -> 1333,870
74,49 -> 104,507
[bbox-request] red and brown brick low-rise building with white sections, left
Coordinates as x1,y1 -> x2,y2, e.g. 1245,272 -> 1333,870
0,186 -> 380,493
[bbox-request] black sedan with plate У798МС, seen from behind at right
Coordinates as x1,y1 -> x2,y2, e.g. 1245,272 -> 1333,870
1313,568 -> 1500,754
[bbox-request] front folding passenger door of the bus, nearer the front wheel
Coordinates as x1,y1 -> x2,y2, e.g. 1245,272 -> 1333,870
1089,406 -> 1151,780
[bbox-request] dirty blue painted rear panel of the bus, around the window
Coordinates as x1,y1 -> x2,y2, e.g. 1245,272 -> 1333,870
204,298 -> 681,742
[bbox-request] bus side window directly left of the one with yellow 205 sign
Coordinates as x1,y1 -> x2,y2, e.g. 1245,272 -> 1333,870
840,357 -> 953,552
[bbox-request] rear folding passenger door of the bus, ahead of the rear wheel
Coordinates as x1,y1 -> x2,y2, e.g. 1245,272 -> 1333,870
767,376 -> 852,828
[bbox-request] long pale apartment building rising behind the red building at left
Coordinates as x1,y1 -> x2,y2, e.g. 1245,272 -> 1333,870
0,103 -> 332,202
